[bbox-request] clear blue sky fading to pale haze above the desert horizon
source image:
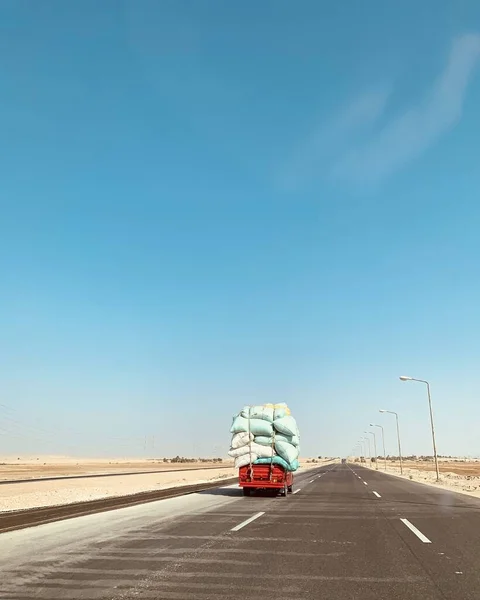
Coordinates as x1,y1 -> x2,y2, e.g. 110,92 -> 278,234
0,0 -> 480,456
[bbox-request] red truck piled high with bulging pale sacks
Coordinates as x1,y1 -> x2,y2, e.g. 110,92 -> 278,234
228,404 -> 300,497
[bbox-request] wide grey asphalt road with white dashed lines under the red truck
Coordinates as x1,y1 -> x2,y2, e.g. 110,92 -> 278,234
0,464 -> 480,600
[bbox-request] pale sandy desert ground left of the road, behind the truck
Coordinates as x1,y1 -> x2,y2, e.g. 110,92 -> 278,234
0,459 -> 325,512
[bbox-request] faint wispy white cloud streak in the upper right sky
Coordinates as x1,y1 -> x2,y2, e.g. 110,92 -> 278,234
284,34 -> 480,184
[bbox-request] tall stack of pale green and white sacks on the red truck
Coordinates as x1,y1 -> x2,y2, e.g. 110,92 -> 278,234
228,403 -> 300,471
